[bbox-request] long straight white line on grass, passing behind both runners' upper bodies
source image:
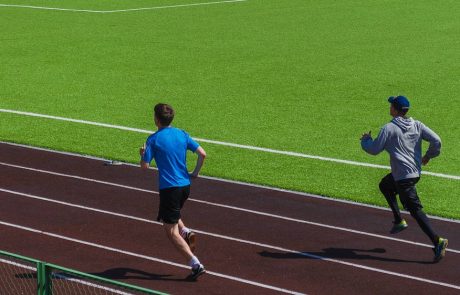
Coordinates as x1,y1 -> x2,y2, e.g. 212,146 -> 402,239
0,109 -> 460,180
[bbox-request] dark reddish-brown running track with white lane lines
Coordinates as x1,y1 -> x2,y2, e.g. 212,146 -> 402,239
0,143 -> 460,294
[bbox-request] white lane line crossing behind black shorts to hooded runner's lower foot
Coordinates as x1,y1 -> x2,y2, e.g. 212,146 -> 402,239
0,162 -> 460,253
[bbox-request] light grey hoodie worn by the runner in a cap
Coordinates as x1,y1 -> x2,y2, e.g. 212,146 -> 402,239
361,117 -> 441,181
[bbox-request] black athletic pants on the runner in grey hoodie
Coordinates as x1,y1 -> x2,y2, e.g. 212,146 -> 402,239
379,173 -> 439,245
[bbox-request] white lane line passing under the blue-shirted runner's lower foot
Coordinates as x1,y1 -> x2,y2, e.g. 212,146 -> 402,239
0,221 -> 304,294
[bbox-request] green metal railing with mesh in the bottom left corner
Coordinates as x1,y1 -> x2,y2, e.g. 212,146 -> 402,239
0,251 -> 166,295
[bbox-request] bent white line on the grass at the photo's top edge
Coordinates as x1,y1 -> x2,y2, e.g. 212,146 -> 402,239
0,0 -> 247,13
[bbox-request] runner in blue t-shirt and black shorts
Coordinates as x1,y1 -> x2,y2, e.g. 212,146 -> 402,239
139,103 -> 206,279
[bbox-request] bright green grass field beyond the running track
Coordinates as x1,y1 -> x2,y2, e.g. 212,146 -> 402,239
0,0 -> 460,219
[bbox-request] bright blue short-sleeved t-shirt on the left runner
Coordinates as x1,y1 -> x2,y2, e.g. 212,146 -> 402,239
142,127 -> 200,189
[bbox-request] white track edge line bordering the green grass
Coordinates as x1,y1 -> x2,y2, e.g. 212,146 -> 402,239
5,141 -> 460,223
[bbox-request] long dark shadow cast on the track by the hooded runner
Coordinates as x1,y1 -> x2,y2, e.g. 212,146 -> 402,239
259,248 -> 434,264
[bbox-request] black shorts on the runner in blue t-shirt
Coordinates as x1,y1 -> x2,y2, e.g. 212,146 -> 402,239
157,185 -> 190,224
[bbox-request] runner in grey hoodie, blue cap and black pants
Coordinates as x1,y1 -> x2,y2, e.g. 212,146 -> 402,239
361,96 -> 448,262
